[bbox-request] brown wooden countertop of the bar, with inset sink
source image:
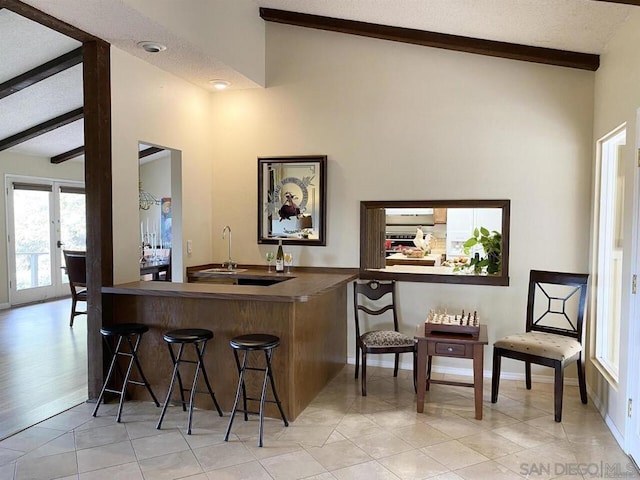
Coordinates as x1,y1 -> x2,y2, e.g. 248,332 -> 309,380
102,265 -> 358,302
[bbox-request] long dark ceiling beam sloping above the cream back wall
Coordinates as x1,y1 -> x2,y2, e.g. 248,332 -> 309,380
260,8 -> 600,71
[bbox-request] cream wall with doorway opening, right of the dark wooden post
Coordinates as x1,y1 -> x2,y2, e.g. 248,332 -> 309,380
111,48 -> 213,283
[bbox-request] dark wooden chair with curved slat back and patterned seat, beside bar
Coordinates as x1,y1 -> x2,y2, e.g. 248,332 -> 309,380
353,280 -> 416,397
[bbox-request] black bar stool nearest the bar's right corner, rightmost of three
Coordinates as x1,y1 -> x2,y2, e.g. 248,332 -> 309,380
224,333 -> 289,447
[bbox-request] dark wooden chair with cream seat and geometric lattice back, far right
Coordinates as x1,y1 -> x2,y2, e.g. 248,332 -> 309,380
491,270 -> 589,422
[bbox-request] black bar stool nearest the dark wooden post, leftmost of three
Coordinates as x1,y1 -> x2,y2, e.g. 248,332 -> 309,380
93,323 -> 160,423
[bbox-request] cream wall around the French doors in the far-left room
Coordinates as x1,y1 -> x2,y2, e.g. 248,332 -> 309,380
0,151 -> 84,305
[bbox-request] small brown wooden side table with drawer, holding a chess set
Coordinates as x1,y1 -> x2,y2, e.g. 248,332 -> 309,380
415,325 -> 489,420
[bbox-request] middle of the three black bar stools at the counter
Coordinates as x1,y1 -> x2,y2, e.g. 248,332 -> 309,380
156,328 -> 222,435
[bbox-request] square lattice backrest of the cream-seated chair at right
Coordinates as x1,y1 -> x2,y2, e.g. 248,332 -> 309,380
527,270 -> 589,343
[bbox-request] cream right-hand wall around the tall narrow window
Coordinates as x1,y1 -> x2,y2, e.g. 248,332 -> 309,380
588,9 -> 640,446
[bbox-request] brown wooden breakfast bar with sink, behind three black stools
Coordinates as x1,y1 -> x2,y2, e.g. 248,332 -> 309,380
102,265 -> 357,420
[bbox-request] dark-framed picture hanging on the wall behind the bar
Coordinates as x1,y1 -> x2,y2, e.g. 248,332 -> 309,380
258,155 -> 327,246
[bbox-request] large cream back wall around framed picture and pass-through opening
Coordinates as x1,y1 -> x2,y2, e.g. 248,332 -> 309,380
211,24 -> 594,375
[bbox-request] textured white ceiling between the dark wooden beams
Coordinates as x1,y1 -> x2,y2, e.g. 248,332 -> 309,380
0,0 -> 640,156
